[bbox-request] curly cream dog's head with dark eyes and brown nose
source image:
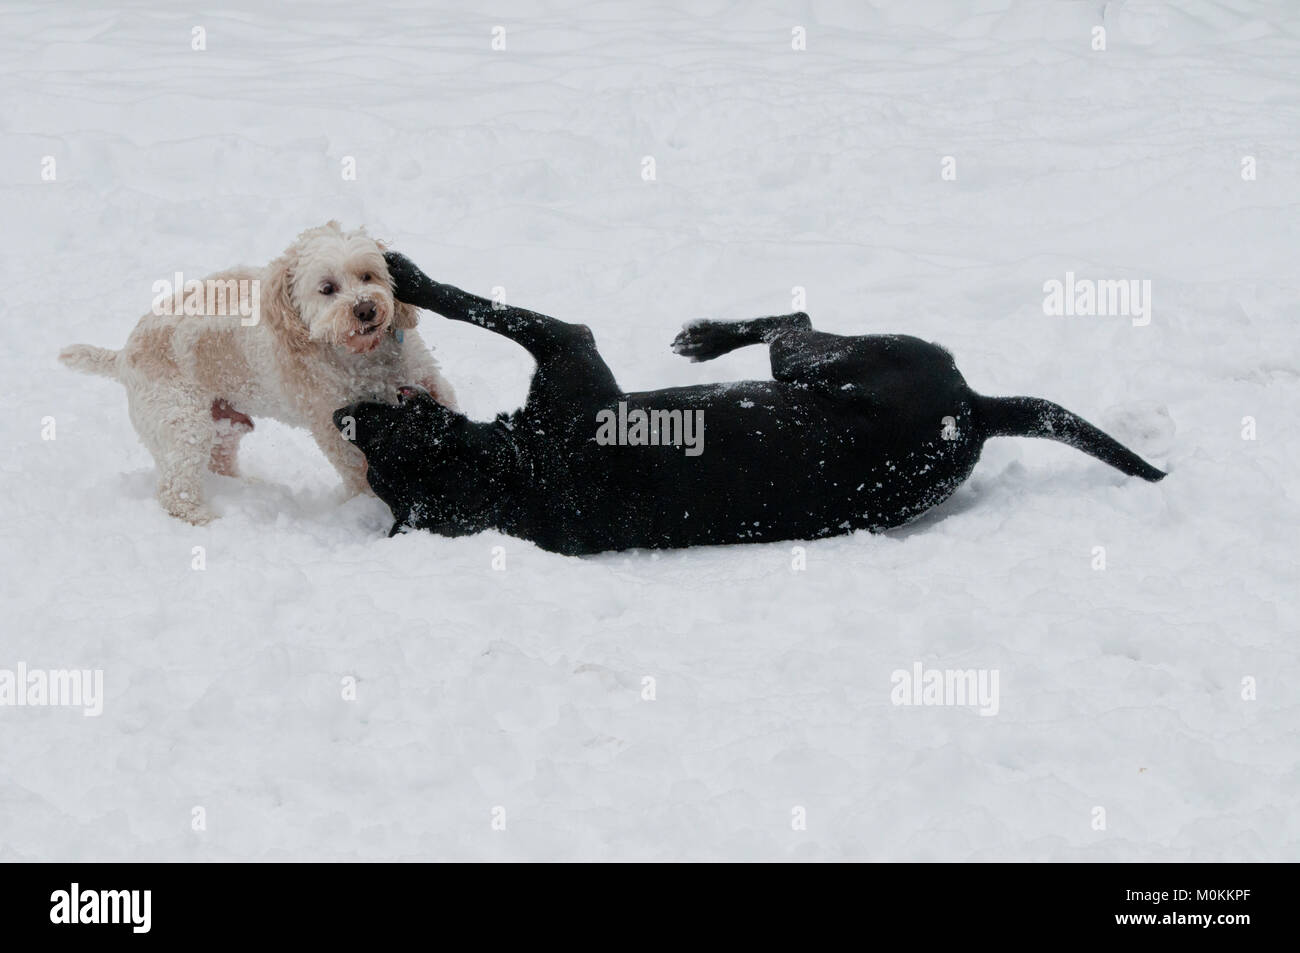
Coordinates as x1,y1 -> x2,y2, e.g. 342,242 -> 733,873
261,221 -> 417,354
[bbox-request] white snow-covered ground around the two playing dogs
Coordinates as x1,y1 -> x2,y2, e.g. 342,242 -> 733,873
0,0 -> 1300,859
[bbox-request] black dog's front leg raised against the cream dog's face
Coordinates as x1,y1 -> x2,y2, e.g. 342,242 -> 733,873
384,251 -> 618,394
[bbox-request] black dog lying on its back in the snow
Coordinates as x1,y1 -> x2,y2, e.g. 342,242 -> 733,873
334,254 -> 1165,554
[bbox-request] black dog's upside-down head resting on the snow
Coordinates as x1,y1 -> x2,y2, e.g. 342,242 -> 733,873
334,387 -> 512,536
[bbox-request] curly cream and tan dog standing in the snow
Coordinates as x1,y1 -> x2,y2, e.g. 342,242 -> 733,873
59,221 -> 455,524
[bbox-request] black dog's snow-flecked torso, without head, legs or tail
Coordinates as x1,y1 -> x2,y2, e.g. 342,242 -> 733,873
521,381 -> 980,554
